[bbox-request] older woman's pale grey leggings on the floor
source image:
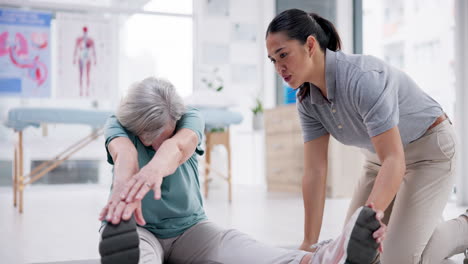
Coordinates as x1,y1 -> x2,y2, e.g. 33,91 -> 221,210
138,221 -> 307,264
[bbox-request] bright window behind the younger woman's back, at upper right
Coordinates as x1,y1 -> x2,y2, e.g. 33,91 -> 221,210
363,0 -> 455,118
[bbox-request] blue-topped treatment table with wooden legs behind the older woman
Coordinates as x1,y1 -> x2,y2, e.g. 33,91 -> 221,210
5,107 -> 242,213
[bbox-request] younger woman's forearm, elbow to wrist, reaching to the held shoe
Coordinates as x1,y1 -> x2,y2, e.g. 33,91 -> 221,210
366,157 -> 406,211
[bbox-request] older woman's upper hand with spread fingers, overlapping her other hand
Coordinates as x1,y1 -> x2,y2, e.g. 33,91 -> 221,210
120,166 -> 163,203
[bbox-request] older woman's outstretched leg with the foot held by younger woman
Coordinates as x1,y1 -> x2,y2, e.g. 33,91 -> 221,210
167,214 -> 380,264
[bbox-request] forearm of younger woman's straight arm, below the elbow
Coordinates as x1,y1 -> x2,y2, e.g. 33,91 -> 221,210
302,170 -> 327,245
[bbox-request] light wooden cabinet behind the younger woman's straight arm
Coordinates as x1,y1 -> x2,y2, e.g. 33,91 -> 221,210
265,104 -> 363,198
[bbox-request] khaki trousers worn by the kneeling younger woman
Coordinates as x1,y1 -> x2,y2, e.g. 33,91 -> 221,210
346,120 -> 468,264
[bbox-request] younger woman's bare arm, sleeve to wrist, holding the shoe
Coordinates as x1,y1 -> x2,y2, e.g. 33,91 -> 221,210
366,126 -> 406,211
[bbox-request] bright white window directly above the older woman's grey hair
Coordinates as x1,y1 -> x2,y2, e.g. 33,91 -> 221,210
119,0 -> 193,96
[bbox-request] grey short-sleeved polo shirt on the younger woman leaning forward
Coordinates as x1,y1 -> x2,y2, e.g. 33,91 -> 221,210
297,49 -> 443,152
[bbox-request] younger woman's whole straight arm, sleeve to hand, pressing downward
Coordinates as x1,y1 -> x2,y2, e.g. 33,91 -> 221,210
300,134 -> 330,251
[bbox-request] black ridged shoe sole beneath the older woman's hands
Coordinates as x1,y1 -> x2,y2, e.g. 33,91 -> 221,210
99,216 -> 140,264
